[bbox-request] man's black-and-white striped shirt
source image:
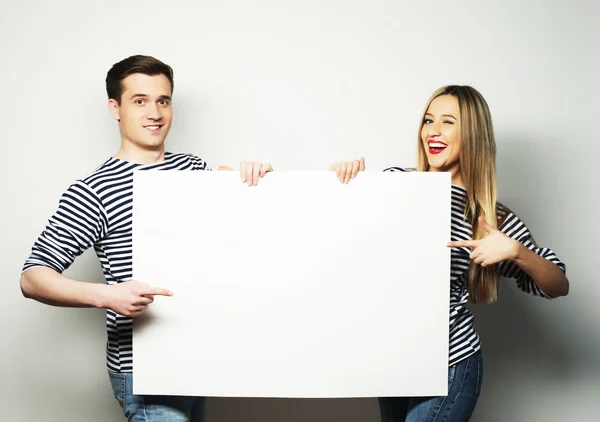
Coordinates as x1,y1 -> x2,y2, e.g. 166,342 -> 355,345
23,152 -> 209,372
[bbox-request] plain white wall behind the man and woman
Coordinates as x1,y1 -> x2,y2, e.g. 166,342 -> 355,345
0,0 -> 600,422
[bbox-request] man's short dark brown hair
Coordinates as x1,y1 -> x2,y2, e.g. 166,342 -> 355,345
106,55 -> 175,104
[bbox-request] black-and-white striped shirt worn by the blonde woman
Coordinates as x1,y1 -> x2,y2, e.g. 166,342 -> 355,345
384,167 -> 566,366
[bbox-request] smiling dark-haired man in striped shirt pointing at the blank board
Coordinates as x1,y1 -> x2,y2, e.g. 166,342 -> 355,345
21,56 -> 272,422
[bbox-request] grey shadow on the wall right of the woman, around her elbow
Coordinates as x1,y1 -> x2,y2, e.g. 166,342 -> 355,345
471,133 -> 600,422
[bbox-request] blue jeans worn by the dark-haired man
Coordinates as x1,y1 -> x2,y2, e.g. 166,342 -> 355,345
108,371 -> 206,422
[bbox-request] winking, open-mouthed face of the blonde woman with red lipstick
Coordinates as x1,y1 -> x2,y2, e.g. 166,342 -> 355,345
421,95 -> 462,184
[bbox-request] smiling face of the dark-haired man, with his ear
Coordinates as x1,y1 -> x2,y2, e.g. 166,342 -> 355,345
109,73 -> 173,150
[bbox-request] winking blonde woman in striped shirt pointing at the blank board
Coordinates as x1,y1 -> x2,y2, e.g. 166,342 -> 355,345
331,85 -> 569,422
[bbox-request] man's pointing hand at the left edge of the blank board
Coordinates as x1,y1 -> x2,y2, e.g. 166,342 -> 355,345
103,280 -> 173,317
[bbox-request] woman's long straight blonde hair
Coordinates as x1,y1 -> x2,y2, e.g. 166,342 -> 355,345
417,85 -> 498,303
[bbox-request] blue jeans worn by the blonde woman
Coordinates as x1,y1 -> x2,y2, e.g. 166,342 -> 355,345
379,351 -> 483,422
